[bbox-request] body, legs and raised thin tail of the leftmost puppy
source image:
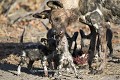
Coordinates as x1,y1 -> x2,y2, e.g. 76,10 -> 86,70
17,29 -> 55,76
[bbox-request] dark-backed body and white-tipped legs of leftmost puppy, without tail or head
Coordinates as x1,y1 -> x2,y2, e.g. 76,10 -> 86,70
18,43 -> 49,76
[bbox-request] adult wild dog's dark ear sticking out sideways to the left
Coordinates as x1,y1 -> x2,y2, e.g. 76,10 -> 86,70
33,10 -> 51,19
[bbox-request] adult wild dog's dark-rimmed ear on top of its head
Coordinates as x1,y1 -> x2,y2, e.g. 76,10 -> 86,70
47,1 -> 63,9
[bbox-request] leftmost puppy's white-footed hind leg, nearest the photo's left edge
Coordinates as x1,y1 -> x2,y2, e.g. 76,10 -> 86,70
17,51 -> 26,75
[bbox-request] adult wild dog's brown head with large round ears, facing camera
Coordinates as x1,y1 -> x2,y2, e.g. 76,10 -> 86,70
33,1 -> 77,37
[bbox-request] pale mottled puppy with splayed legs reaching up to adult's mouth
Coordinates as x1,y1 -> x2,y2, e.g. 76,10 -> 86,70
52,27 -> 78,77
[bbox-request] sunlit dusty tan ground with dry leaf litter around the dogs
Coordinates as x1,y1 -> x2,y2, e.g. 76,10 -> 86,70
0,0 -> 120,80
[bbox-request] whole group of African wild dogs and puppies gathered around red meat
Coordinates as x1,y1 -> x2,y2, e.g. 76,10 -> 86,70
18,1 -> 113,78
